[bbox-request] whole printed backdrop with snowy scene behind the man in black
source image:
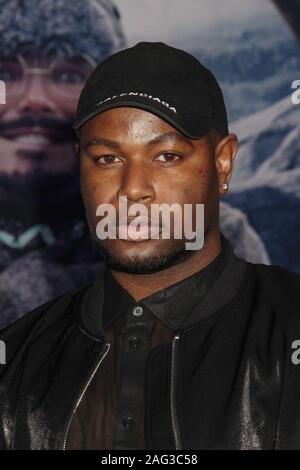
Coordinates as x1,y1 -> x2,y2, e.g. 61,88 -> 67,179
0,0 -> 300,327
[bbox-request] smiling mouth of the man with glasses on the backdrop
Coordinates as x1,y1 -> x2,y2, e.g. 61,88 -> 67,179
1,126 -> 69,145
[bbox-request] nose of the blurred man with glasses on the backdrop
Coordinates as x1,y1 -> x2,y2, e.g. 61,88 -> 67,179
17,75 -> 56,114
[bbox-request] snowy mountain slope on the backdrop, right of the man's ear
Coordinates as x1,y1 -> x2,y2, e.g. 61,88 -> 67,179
224,96 -> 300,272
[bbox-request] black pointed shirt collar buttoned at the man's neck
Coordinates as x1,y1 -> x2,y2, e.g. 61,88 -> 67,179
103,233 -> 229,330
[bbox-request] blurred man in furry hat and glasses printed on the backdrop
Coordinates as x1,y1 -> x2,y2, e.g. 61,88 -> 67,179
0,0 -> 125,327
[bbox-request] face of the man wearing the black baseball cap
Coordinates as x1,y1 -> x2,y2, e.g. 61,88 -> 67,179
80,107 -> 224,273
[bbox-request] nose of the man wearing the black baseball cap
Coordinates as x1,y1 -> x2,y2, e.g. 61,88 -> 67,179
118,162 -> 155,202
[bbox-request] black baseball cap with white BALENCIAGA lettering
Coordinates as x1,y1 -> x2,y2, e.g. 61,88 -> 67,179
73,42 -> 228,139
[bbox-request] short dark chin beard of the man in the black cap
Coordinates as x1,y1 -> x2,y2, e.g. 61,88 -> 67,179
92,238 -> 195,274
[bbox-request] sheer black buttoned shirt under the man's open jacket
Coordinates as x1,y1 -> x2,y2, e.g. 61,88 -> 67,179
67,234 -> 228,450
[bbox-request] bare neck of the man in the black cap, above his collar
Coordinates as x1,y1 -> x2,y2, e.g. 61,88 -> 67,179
112,231 -> 221,301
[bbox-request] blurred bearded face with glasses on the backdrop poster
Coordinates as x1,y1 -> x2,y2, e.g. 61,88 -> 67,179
0,52 -> 92,205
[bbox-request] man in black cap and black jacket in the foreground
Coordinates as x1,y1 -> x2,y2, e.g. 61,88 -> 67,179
0,42 -> 300,450
